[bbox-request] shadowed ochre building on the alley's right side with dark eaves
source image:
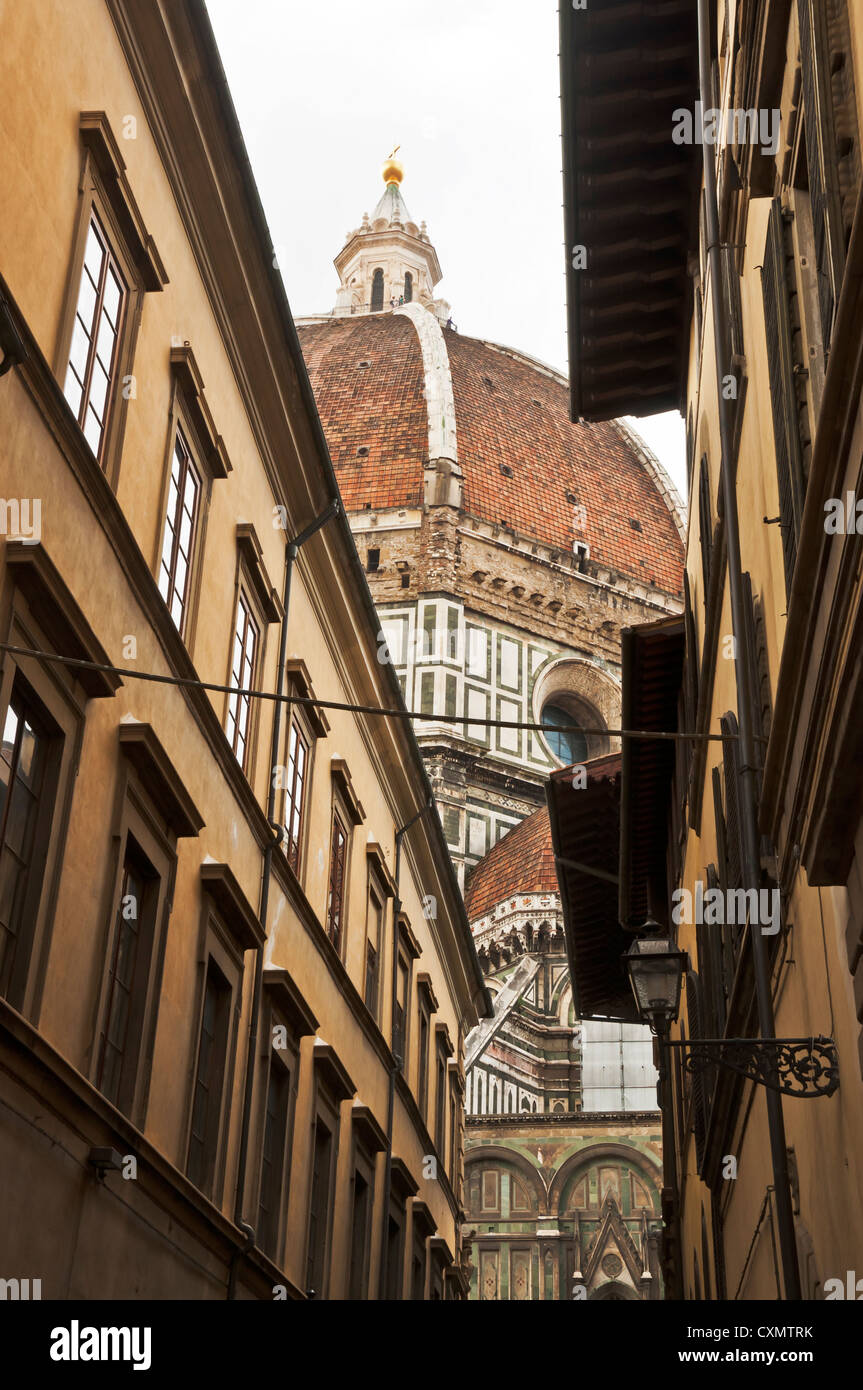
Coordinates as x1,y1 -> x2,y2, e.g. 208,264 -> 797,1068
557,0 -> 863,1300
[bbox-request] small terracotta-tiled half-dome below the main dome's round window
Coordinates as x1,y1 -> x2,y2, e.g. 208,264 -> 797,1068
464,806 -> 560,922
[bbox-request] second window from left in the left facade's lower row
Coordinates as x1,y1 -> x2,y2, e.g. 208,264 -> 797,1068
96,835 -> 160,1111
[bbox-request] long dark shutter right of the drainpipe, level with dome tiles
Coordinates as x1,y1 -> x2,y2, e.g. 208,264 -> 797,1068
762,197 -> 805,594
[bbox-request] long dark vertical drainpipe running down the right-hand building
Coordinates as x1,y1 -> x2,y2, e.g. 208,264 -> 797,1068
698,0 -> 800,1301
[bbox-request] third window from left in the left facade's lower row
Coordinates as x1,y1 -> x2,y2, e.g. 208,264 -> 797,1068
186,958 -> 231,1195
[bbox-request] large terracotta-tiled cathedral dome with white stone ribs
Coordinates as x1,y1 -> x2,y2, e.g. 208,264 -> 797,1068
297,309 -> 684,598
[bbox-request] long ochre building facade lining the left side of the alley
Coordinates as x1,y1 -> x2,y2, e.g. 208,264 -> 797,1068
0,0 -> 488,1300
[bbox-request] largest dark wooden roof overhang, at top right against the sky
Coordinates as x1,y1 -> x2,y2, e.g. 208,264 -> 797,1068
560,0 -> 702,420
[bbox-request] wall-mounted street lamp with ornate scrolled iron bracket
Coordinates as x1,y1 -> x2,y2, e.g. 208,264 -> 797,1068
624,920 -> 839,1099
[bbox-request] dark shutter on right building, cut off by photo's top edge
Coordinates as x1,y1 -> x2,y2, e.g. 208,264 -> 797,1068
798,0 -> 845,352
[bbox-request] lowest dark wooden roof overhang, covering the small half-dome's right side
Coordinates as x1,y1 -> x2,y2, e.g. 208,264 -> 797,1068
546,753 -> 638,1023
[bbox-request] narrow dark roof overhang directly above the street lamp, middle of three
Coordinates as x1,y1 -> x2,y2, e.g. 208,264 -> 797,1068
618,614 -> 685,931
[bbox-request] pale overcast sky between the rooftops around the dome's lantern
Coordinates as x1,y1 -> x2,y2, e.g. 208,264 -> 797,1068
207,0 -> 685,496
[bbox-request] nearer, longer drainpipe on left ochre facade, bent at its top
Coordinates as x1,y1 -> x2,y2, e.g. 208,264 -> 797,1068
228,498 -> 340,1298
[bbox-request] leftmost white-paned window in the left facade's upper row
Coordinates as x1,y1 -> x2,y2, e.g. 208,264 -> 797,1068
63,211 -> 128,459
